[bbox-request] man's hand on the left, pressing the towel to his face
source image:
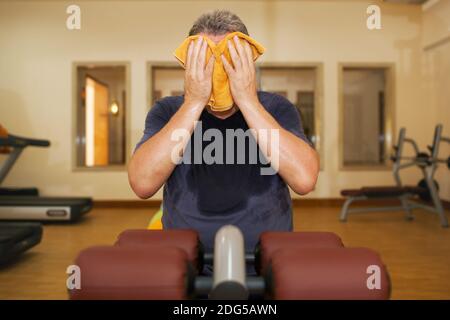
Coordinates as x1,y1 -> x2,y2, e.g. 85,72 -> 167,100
184,36 -> 214,107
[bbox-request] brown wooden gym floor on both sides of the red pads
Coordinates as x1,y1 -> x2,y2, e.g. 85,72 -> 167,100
0,204 -> 450,299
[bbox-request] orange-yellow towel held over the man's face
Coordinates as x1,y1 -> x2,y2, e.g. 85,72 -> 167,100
174,32 -> 265,111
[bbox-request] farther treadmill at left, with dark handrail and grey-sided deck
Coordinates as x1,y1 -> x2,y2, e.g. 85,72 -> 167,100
0,133 -> 93,222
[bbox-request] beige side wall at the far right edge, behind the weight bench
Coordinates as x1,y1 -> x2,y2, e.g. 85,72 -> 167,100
423,0 -> 450,201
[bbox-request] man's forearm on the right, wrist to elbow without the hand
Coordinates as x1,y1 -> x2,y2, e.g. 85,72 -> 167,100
240,102 -> 319,194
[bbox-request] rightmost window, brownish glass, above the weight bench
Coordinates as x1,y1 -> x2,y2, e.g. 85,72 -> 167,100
340,66 -> 392,168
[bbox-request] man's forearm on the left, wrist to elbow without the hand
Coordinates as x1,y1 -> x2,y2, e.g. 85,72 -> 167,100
128,102 -> 204,199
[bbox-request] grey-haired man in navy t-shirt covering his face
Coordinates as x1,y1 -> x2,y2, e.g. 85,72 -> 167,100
128,10 -> 319,272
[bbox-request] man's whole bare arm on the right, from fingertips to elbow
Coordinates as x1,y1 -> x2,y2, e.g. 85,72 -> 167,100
221,38 -> 319,194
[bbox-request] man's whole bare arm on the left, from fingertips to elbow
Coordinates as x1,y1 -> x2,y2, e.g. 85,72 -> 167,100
128,37 -> 214,199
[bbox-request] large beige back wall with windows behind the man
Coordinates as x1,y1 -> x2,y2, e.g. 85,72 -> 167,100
0,0 -> 437,199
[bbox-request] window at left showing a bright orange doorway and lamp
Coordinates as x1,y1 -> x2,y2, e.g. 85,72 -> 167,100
75,64 -> 127,168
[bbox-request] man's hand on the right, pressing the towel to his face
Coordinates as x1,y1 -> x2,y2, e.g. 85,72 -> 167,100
221,36 -> 258,107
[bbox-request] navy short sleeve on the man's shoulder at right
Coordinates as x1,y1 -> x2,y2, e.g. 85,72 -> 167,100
272,95 -> 313,147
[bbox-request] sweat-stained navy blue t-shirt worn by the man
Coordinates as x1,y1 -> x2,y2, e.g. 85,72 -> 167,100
136,91 -> 309,262
